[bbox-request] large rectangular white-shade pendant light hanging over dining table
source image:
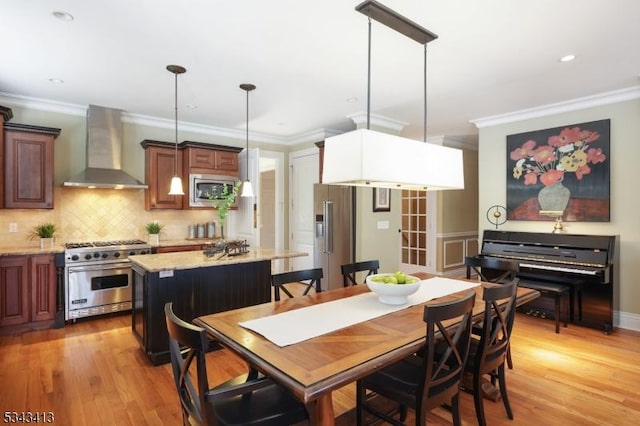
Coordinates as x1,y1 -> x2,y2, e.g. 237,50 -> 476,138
322,0 -> 464,190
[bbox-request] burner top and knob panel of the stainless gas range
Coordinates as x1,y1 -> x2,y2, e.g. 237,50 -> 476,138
64,240 -> 151,265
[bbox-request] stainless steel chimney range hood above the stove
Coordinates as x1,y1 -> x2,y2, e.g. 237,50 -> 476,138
63,105 -> 148,189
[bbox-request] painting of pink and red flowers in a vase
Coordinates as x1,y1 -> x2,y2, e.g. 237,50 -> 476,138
507,120 -> 611,222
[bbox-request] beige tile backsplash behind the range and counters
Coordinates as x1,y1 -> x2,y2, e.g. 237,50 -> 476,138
0,187 -> 225,247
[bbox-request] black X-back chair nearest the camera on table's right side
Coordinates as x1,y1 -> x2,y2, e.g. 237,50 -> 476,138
356,291 -> 476,425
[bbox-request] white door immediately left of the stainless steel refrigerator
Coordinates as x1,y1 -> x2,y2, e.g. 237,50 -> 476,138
289,148 -> 320,270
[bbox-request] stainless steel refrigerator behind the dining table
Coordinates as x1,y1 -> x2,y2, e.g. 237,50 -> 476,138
313,184 -> 355,290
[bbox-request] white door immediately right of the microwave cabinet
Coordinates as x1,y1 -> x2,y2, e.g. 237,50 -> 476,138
234,148 -> 260,247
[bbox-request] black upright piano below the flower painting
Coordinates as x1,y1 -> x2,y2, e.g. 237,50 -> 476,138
479,230 -> 619,334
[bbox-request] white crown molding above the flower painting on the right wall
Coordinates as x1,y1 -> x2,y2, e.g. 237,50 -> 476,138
469,86 -> 640,129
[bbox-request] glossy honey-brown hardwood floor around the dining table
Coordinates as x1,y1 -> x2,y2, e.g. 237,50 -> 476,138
0,314 -> 640,426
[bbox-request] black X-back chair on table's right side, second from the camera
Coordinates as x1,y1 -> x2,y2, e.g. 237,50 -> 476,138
463,278 -> 519,426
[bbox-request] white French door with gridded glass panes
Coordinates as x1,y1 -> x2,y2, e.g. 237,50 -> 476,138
399,190 -> 436,273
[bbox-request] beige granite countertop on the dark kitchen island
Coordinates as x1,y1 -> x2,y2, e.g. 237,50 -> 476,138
129,247 -> 309,272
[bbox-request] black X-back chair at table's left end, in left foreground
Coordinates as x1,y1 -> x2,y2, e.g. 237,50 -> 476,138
164,302 -> 309,426
